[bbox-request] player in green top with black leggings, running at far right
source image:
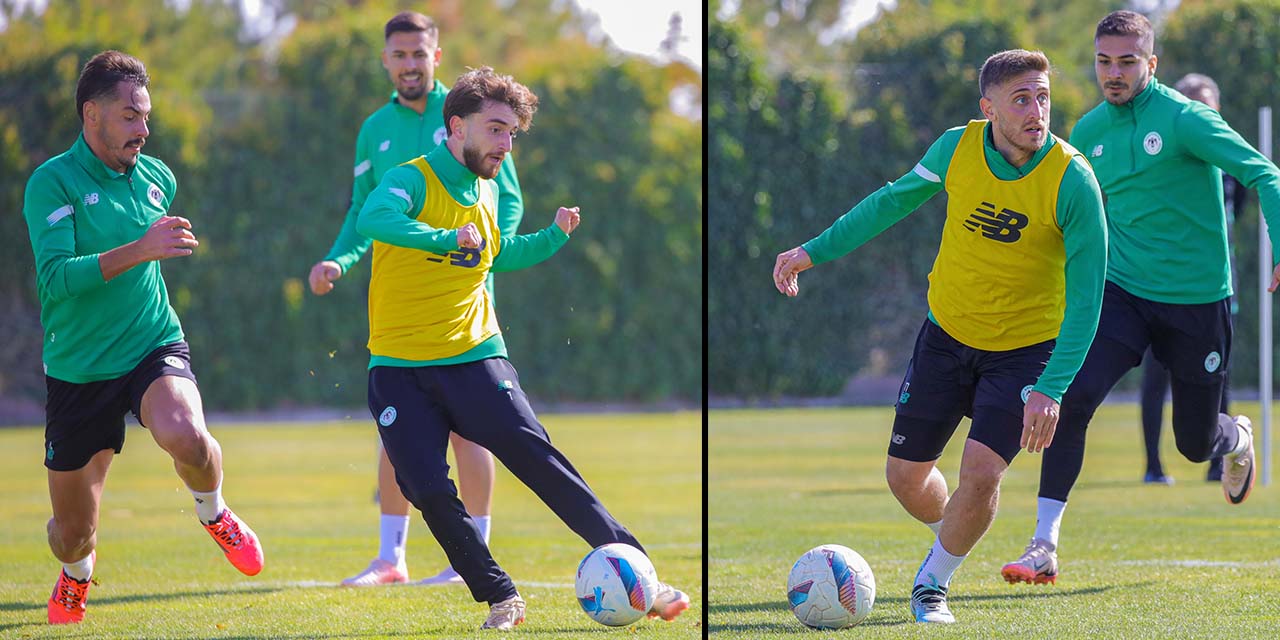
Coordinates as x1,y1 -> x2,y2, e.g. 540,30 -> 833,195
1001,10 -> 1280,584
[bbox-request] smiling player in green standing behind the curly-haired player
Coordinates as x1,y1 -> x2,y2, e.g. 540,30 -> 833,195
310,12 -> 525,586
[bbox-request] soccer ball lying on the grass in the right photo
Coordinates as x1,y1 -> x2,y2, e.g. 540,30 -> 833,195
787,544 -> 876,628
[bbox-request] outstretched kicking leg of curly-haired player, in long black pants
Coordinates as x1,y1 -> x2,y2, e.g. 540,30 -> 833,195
440,358 -> 689,620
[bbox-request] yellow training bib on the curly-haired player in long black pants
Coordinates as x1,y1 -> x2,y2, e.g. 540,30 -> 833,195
369,157 -> 502,360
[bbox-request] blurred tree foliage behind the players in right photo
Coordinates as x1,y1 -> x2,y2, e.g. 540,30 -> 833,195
708,0 -> 1280,398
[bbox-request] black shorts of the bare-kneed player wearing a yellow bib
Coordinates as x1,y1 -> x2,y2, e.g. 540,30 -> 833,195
888,319 -> 1055,462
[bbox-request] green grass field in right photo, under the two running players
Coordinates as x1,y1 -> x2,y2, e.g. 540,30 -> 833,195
707,403 -> 1280,640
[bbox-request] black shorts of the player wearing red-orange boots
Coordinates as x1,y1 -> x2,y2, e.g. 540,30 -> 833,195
45,342 -> 196,471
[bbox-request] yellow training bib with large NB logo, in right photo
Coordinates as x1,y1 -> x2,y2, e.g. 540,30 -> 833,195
929,120 -> 1079,351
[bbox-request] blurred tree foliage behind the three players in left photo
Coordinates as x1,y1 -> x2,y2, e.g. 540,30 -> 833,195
0,0 -> 703,410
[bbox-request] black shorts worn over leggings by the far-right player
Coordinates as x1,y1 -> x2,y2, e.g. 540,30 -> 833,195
1098,280 -> 1231,385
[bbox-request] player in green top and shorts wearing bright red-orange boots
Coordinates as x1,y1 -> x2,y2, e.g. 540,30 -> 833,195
23,51 -> 262,625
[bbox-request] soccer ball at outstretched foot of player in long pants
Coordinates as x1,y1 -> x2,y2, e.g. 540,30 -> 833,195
573,543 -> 658,627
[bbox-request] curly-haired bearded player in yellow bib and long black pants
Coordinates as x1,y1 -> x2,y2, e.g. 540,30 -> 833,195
356,67 -> 689,630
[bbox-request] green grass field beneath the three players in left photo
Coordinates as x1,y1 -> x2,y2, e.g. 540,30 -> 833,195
0,413 -> 703,639
